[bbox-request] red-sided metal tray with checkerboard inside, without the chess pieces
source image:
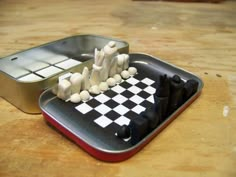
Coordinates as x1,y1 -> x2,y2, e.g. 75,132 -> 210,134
39,54 -> 203,161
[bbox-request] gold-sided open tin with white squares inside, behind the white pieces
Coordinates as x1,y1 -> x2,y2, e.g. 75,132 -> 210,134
0,35 -> 129,113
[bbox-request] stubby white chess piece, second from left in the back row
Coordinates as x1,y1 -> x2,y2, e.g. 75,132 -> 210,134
70,73 -> 83,94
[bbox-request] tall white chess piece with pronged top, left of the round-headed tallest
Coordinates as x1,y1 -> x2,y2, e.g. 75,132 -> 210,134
90,48 -> 104,86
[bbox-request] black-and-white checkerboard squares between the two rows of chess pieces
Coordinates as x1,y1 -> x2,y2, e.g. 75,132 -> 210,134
75,74 -> 156,128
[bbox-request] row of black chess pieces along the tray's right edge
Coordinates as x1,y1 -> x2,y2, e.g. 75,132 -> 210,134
117,75 -> 198,145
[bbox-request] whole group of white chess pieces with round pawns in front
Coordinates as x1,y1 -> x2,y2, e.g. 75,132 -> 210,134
52,41 -> 137,103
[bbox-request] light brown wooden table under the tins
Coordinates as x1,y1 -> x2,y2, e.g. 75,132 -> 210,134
0,0 -> 236,177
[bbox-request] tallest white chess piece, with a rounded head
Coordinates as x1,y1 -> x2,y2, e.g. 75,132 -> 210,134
101,41 -> 118,81
